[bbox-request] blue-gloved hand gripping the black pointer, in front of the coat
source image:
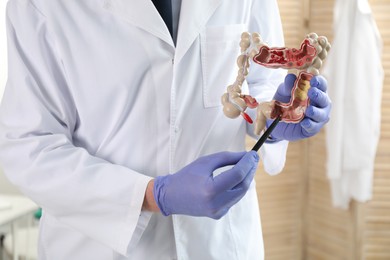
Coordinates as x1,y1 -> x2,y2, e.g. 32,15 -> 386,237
153,151 -> 259,219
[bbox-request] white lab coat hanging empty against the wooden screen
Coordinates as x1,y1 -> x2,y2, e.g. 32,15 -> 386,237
323,0 -> 383,208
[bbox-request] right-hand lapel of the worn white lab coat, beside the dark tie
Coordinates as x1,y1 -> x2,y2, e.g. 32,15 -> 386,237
175,0 -> 222,64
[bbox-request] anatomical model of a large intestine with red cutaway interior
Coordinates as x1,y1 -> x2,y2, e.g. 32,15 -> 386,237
222,32 -> 330,135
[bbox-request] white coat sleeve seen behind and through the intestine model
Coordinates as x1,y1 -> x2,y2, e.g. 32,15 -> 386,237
247,0 -> 288,175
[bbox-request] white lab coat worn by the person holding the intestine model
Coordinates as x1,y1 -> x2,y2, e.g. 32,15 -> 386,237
0,0 -> 287,260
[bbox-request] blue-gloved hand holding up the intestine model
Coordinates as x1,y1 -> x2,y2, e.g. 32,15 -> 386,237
267,74 -> 331,141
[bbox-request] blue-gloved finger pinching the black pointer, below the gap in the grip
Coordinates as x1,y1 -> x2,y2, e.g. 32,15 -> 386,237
214,151 -> 259,192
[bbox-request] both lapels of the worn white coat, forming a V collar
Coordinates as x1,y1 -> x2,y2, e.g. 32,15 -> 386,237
103,0 -> 223,64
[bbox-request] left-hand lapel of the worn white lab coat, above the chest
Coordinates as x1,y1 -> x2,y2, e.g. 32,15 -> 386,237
103,0 -> 174,47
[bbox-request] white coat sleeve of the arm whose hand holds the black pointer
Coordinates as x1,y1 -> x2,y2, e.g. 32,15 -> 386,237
0,1 -> 151,254
